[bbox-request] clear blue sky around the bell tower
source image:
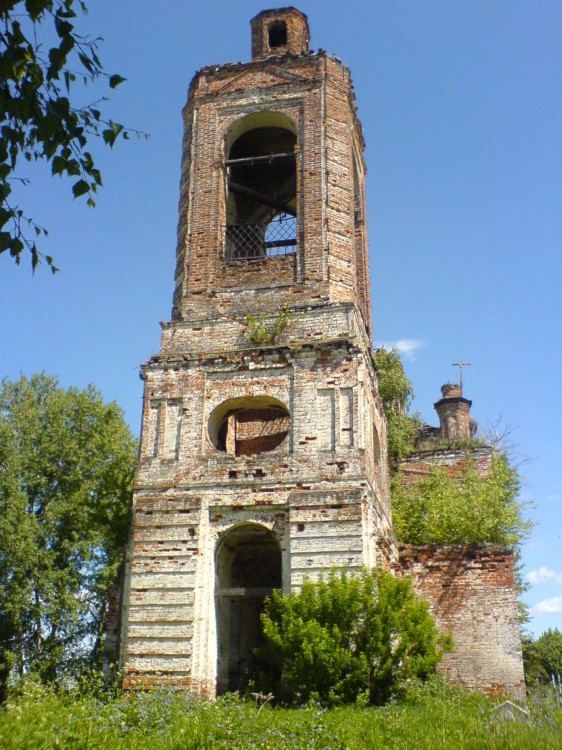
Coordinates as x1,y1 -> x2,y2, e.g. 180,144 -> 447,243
0,0 -> 562,634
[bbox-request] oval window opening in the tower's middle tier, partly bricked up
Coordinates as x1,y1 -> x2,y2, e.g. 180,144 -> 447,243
208,396 -> 291,456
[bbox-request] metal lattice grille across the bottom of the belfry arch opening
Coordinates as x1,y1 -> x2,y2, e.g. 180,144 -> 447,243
225,216 -> 297,260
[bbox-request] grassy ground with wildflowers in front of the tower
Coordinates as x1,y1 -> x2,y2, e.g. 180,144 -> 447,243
0,682 -> 562,750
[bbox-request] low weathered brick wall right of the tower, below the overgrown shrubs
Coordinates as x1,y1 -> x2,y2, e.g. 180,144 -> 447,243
400,545 -> 525,697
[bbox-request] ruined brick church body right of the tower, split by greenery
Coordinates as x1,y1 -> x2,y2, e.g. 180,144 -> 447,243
399,383 -> 525,697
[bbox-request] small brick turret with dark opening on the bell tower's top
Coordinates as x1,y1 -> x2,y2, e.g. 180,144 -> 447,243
250,8 -> 310,60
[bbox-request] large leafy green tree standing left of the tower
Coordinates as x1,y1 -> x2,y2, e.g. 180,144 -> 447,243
0,374 -> 136,698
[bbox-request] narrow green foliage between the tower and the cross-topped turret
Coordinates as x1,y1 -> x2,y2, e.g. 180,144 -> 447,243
375,349 -> 420,465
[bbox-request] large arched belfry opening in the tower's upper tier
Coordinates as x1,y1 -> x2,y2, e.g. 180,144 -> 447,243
225,112 -> 297,260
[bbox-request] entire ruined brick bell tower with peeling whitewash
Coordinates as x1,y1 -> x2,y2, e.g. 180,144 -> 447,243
121,7 -> 397,696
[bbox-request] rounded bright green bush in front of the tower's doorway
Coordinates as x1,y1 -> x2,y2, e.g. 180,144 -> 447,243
257,569 -> 451,705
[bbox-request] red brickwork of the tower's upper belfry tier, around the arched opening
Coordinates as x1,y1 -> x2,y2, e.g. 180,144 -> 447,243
173,48 -> 371,340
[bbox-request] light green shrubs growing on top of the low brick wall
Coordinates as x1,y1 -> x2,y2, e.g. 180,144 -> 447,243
392,452 -> 531,547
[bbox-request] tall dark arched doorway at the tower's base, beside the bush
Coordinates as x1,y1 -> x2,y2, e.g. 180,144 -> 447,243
215,523 -> 281,693
